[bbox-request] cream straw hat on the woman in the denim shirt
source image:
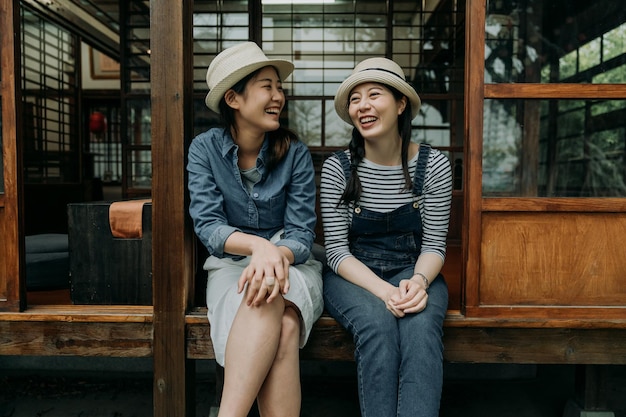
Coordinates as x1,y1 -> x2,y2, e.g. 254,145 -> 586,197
204,42 -> 293,113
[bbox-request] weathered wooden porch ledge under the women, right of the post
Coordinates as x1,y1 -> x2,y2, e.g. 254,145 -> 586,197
185,307 -> 626,365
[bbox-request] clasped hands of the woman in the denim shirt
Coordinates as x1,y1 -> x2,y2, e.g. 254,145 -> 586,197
238,240 -> 290,306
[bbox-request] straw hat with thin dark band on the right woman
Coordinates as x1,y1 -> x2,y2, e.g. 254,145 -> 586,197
335,58 -> 422,124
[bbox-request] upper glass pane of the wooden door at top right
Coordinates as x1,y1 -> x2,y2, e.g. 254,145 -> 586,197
485,0 -> 626,84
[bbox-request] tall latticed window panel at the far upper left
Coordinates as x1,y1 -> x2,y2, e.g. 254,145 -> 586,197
20,7 -> 81,183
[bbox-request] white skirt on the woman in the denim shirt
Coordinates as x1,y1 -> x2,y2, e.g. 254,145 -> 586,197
204,236 -> 324,366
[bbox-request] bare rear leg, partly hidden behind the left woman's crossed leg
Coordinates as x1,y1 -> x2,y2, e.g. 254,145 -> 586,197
257,307 -> 302,417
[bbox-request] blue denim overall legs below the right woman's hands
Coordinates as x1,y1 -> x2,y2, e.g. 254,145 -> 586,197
323,266 -> 448,417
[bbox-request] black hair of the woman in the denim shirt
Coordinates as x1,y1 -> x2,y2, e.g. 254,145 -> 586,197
219,67 -> 298,171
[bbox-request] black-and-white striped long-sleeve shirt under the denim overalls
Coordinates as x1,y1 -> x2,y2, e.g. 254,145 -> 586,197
320,149 -> 452,272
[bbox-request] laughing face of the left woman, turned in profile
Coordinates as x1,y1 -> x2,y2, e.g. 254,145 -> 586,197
225,67 -> 285,132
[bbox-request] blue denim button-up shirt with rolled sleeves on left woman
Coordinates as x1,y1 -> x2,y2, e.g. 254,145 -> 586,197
187,128 -> 317,264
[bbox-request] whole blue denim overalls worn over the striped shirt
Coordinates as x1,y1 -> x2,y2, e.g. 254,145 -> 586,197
324,144 -> 448,417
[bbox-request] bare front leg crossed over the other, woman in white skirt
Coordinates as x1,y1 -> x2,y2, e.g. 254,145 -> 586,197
218,297 -> 285,417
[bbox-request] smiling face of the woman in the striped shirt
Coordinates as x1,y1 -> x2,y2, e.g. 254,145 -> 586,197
348,83 -> 406,140
